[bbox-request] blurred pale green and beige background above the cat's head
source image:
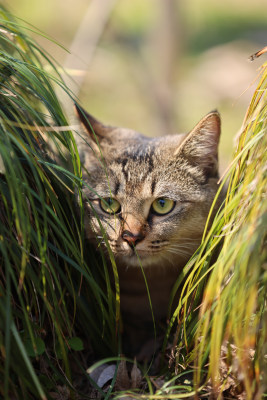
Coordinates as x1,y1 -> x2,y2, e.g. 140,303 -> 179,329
4,0 -> 267,171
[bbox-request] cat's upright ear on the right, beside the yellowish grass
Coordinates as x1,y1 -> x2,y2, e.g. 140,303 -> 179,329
175,111 -> 221,175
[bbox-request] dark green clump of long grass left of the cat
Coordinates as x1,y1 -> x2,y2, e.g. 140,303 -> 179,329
0,6 -> 116,399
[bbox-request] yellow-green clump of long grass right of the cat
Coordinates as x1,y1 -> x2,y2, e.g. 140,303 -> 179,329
166,60 -> 267,399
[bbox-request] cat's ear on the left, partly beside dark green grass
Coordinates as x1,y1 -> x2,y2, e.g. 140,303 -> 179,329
75,104 -> 114,142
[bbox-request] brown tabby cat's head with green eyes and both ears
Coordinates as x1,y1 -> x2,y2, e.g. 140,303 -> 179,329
77,107 -> 220,267
